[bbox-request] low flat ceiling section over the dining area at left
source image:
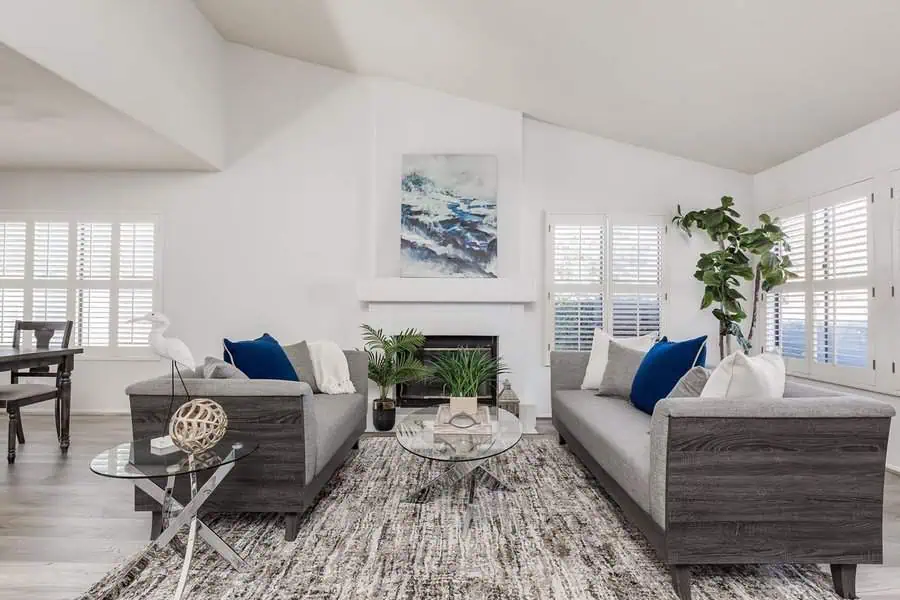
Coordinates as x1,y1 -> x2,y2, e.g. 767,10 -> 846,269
0,44 -> 209,170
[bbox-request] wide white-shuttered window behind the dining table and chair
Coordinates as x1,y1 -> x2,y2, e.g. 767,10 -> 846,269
0,214 -> 159,356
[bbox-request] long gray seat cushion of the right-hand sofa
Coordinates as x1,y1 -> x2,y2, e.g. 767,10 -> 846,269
553,390 -> 650,513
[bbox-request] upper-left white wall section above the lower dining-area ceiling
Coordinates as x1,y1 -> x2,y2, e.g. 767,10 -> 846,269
0,0 -> 224,168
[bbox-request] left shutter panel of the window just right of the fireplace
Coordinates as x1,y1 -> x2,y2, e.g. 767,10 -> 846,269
548,216 -> 606,352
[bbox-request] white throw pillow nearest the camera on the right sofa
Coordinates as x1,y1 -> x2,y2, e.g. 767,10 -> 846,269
700,352 -> 785,398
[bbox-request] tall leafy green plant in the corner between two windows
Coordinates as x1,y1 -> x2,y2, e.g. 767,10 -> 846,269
672,196 -> 796,358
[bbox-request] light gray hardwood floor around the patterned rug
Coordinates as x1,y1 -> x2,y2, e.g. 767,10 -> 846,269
0,415 -> 900,600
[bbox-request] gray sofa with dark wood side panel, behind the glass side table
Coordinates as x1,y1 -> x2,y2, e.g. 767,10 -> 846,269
126,351 -> 368,541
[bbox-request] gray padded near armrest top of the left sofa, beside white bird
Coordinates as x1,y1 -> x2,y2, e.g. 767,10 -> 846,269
125,376 -> 313,398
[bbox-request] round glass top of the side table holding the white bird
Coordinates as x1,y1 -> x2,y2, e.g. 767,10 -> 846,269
91,433 -> 259,479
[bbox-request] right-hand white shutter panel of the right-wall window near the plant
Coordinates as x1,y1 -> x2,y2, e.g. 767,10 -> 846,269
811,194 -> 870,367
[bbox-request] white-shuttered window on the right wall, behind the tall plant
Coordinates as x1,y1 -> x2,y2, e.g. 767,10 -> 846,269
766,182 -> 874,385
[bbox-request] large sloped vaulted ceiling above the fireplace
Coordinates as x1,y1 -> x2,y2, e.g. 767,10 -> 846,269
196,0 -> 900,173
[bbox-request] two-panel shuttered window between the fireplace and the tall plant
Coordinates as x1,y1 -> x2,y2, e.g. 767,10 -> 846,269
547,215 -> 665,352
